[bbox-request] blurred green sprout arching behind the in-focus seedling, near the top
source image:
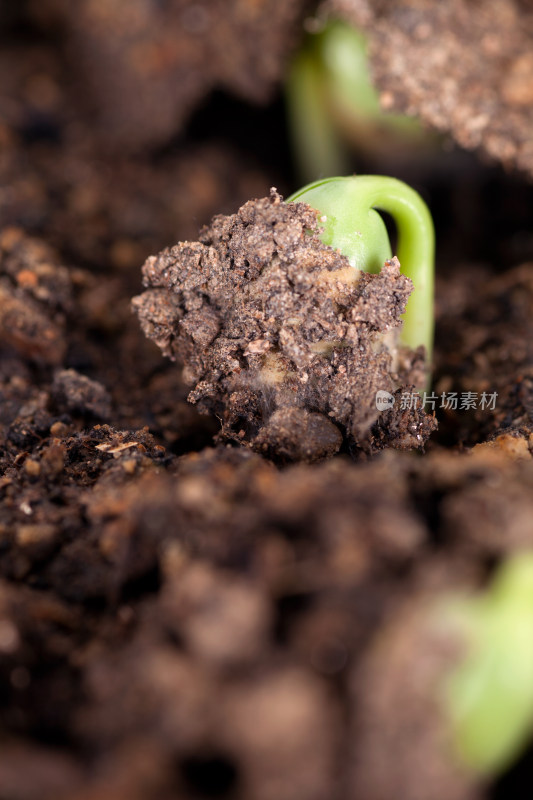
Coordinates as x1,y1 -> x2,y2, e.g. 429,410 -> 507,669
286,21 -> 433,181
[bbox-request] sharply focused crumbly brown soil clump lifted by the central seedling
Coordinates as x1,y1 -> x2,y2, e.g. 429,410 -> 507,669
133,190 -> 435,461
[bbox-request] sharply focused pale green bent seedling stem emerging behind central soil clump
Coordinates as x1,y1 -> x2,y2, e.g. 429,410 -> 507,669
287,175 -> 435,364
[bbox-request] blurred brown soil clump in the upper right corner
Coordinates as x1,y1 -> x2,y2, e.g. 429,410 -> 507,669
325,0 -> 533,175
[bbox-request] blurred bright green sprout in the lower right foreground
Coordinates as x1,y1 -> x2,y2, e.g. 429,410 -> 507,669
445,553 -> 533,776
